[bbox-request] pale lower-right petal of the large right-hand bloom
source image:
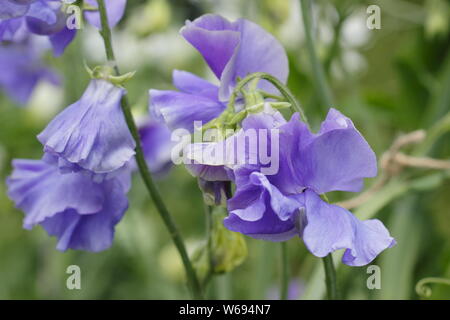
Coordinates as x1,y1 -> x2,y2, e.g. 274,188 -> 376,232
302,190 -> 395,266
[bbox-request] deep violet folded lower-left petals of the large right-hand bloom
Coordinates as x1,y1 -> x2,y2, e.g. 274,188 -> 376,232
224,169 -> 301,241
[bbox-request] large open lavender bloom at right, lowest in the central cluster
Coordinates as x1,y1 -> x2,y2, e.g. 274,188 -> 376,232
216,109 -> 395,266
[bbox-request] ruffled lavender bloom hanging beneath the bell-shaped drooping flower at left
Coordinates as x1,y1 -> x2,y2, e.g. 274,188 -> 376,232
7,155 -> 130,252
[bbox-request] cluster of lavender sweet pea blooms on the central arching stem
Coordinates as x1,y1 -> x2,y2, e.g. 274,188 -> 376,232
150,15 -> 395,266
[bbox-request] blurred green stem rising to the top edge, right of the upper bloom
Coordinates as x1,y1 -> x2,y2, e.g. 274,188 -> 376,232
300,0 -> 333,108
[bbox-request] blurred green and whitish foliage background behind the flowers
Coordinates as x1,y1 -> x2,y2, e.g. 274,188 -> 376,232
0,0 -> 450,299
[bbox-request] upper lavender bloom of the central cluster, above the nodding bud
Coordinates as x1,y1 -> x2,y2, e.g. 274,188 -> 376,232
150,14 -> 289,185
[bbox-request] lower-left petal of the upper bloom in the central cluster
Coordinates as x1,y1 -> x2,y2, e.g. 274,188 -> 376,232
150,90 -> 225,132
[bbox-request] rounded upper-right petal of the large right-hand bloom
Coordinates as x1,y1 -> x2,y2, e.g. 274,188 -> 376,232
296,109 -> 377,193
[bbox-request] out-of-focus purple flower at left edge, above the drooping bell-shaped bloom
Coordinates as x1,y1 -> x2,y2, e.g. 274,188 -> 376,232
0,42 -> 60,105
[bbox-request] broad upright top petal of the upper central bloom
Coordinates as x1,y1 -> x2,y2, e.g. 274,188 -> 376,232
180,14 -> 289,101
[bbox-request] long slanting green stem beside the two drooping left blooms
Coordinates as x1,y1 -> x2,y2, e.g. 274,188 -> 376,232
97,0 -> 202,299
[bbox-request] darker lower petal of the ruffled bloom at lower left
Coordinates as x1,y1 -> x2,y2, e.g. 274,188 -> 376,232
42,180 -> 128,252
